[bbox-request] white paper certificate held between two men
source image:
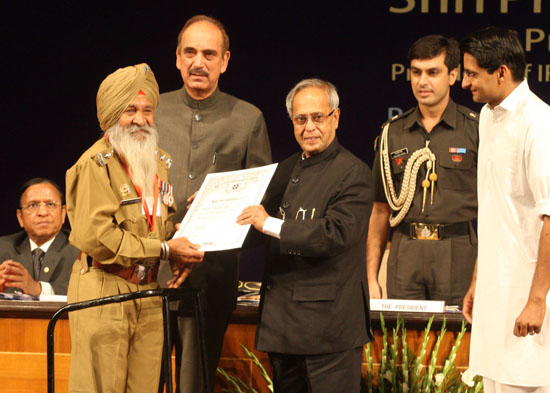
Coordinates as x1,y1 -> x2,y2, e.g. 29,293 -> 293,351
174,164 -> 277,251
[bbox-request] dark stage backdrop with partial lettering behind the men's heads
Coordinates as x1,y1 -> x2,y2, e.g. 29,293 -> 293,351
0,0 -> 550,279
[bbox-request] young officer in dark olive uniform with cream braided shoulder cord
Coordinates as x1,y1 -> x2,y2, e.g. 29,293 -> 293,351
367,35 -> 479,306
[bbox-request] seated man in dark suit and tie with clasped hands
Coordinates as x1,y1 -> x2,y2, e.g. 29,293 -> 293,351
0,178 -> 79,296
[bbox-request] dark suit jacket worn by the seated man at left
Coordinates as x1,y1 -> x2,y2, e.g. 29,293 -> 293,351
0,229 -> 79,295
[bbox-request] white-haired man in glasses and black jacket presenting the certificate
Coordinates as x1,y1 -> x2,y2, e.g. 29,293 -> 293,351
238,79 -> 372,393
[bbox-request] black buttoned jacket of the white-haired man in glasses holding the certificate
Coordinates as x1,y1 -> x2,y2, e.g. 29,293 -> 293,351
256,140 -> 373,355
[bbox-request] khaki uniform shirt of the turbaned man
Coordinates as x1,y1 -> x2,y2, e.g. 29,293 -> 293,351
66,138 -> 175,267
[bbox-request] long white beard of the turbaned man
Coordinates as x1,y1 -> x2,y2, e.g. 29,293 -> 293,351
106,123 -> 158,197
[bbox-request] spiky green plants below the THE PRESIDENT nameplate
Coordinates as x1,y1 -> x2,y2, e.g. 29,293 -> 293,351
362,313 -> 483,393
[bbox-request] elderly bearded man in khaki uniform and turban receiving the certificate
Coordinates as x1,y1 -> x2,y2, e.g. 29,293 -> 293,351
67,64 -> 204,393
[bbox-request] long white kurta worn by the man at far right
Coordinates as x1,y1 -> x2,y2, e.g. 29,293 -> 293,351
470,81 -> 550,386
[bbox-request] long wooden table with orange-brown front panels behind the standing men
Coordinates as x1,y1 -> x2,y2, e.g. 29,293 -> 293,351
0,300 -> 470,393
